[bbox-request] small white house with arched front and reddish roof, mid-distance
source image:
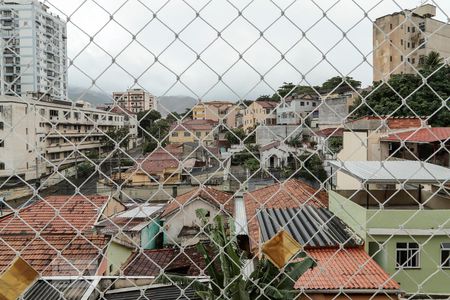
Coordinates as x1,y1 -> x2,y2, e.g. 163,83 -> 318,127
259,141 -> 300,169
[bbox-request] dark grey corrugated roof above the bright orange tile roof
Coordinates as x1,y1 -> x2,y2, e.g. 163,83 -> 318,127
258,205 -> 362,247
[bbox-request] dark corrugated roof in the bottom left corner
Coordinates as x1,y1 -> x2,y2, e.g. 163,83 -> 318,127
20,279 -> 92,300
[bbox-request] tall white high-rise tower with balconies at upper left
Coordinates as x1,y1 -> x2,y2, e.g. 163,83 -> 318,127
0,0 -> 67,100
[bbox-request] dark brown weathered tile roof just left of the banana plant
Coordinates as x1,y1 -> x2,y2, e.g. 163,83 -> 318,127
124,246 -> 206,276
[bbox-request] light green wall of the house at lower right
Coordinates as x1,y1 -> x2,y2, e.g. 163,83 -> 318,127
329,191 -> 450,295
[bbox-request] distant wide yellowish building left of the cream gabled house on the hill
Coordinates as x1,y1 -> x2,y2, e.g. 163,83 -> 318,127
192,101 -> 240,128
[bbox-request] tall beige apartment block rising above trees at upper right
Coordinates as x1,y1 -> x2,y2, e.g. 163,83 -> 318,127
373,4 -> 450,81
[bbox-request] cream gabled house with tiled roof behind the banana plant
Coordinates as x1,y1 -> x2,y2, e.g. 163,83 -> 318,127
160,186 -> 234,245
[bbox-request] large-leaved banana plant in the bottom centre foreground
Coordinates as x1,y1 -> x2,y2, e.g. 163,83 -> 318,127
157,209 -> 315,300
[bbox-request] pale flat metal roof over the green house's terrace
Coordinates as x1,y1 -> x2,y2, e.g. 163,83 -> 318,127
330,160 -> 450,183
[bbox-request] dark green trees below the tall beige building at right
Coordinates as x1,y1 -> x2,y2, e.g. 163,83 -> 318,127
354,54 -> 450,127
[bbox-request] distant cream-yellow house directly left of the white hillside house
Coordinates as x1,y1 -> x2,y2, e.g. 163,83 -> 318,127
243,100 -> 279,132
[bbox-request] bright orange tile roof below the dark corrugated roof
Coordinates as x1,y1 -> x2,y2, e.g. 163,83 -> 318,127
295,248 -> 400,290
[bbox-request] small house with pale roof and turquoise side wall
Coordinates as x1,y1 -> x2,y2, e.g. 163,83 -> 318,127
95,204 -> 163,249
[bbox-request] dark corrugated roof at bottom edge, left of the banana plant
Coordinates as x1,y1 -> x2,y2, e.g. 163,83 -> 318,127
105,285 -> 200,300
